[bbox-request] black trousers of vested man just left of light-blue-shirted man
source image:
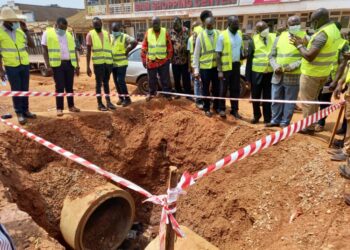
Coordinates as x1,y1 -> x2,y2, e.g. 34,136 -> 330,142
199,67 -> 220,111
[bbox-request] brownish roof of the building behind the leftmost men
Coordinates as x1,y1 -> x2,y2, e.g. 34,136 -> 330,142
16,3 -> 79,22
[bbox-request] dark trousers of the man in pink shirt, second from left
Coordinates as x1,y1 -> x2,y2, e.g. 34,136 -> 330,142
52,61 -> 74,110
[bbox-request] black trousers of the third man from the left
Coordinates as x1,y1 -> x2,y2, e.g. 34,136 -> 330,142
94,63 -> 113,102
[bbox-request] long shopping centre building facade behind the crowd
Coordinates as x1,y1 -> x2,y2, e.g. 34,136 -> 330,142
85,0 -> 350,35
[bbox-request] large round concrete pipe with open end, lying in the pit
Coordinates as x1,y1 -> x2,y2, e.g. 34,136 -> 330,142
60,184 -> 135,250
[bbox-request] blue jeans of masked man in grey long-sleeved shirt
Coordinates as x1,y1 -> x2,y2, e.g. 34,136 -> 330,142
271,82 -> 299,125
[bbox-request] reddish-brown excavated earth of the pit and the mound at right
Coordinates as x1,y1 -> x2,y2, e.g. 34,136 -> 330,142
0,100 -> 350,249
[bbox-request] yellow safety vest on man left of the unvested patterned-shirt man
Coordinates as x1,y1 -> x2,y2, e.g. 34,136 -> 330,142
147,28 -> 167,60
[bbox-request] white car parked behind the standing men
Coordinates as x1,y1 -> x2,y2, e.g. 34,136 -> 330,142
125,44 -> 250,97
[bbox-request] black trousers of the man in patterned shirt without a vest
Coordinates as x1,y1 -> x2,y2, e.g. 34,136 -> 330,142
171,64 -> 191,94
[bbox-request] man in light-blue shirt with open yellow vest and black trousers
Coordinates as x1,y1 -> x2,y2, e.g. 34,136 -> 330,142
215,16 -> 243,119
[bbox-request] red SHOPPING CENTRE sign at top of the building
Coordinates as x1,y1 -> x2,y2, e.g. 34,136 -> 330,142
135,0 -> 238,11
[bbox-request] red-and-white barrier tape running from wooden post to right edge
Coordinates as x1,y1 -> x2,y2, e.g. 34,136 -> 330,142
176,102 -> 344,189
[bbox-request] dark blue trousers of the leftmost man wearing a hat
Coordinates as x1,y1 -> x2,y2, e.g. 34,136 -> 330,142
5,65 -> 29,114
